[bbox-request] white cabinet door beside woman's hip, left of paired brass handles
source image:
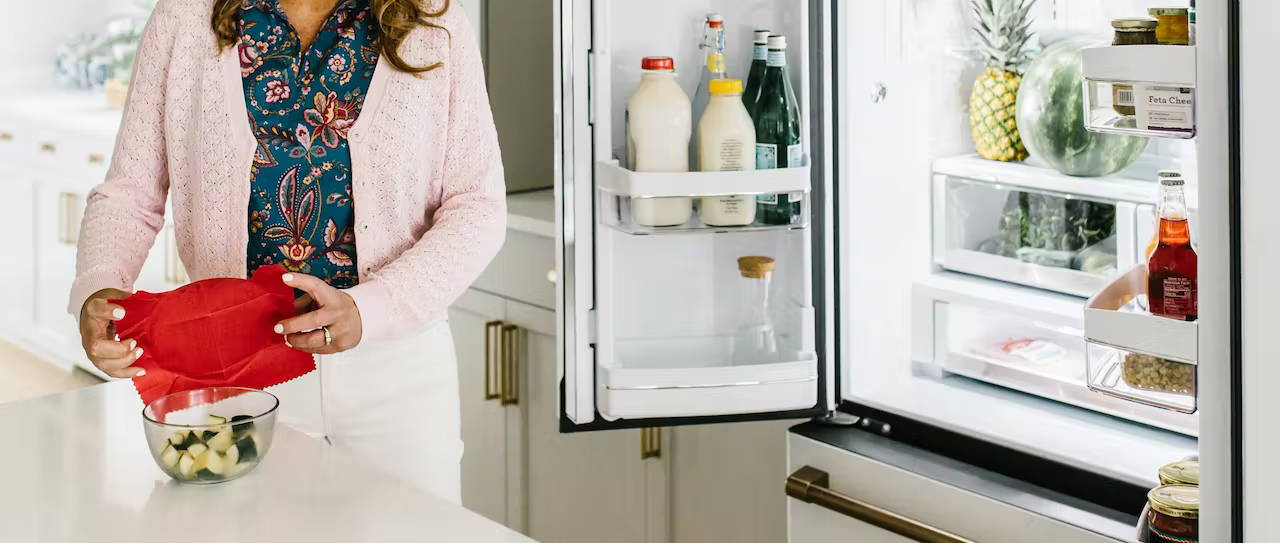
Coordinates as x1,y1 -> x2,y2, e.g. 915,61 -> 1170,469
449,291 -> 513,526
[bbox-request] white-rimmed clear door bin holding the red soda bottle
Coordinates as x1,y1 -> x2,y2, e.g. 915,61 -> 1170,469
1084,264 -> 1199,412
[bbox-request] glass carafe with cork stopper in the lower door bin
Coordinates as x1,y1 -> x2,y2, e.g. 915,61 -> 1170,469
732,256 -> 780,365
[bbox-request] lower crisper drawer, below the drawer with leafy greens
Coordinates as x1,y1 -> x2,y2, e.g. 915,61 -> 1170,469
913,273 -> 1198,435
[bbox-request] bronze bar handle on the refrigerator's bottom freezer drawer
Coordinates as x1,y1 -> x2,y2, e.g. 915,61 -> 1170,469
787,466 -> 974,543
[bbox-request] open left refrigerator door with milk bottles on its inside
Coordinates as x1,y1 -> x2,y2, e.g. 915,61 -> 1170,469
556,0 -> 835,432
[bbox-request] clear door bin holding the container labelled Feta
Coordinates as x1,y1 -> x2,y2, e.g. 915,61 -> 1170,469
1082,45 -> 1196,140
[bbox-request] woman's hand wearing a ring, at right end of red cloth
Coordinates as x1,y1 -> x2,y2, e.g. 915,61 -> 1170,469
275,273 -> 364,355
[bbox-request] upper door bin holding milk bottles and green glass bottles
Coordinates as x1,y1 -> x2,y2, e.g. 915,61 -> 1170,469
595,160 -> 810,234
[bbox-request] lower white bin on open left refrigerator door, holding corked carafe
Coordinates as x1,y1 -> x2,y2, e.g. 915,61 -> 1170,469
596,337 -> 818,420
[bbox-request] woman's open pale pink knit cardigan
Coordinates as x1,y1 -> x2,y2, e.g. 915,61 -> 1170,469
68,0 -> 506,341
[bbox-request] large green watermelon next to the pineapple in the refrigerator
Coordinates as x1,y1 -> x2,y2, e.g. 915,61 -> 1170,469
1016,37 -> 1147,177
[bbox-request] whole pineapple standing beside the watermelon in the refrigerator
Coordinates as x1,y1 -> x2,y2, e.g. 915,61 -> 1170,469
969,0 -> 1036,163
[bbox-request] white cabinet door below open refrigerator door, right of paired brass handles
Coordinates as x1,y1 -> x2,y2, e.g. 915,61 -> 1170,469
507,302 -> 668,543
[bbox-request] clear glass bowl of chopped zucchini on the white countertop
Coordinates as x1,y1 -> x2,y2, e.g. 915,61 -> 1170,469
142,387 -> 280,484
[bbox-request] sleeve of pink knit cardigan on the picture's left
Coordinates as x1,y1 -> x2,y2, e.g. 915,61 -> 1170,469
67,0 -> 179,319
